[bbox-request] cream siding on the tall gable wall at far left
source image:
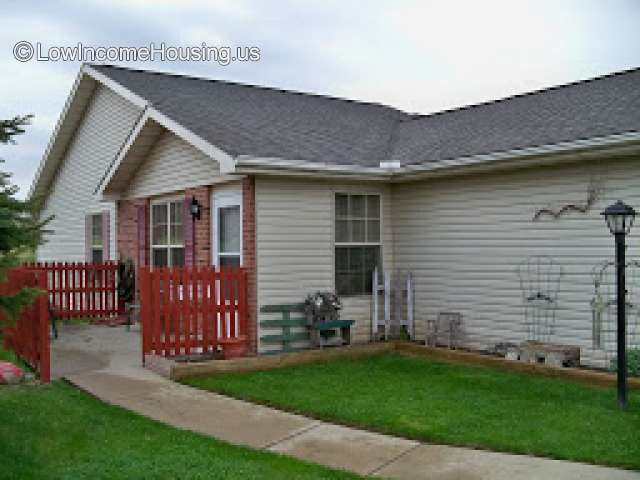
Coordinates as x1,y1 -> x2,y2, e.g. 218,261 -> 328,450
37,86 -> 140,261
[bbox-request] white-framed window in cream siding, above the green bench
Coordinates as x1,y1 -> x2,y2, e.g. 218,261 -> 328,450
335,193 -> 381,295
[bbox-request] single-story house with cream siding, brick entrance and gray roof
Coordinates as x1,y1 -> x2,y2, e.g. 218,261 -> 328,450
30,64 -> 640,363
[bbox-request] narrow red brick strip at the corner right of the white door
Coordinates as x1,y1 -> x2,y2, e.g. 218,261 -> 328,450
242,176 -> 258,353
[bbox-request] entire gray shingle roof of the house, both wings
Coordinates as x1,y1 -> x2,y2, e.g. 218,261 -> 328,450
93,65 -> 640,166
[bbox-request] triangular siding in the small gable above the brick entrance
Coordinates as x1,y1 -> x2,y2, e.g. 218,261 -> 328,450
124,131 -> 220,198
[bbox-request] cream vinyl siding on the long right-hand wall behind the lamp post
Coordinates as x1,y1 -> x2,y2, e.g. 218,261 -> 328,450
392,156 -> 640,362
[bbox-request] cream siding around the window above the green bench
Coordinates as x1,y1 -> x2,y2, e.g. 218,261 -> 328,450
256,177 -> 393,350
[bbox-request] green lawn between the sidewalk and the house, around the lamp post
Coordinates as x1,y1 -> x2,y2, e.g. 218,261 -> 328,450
185,353 -> 640,469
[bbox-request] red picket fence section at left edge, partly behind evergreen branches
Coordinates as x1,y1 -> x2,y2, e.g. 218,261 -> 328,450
0,268 -> 51,383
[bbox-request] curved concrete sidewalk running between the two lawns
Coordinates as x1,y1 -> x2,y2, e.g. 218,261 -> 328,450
53,326 -> 640,480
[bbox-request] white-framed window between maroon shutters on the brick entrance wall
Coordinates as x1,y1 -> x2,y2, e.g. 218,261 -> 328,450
151,199 -> 184,267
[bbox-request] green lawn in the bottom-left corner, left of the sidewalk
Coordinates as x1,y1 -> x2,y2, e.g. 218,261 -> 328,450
0,382 -> 360,480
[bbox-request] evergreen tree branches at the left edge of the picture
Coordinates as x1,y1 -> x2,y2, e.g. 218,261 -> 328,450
0,115 -> 46,319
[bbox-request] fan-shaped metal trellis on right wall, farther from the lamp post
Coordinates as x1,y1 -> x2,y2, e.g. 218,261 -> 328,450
518,256 -> 562,342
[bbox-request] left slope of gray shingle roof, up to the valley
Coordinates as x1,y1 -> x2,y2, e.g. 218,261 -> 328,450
93,66 -> 407,166
